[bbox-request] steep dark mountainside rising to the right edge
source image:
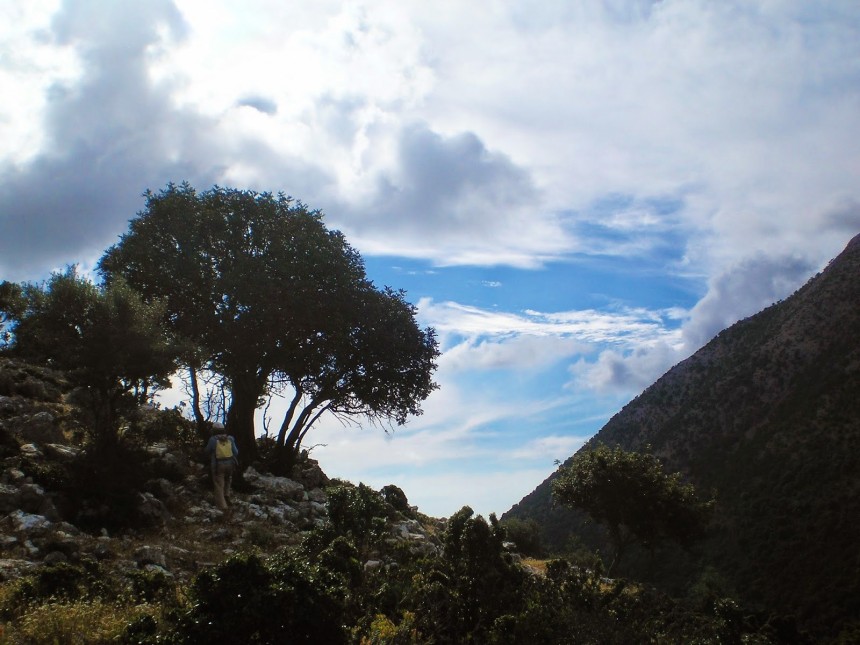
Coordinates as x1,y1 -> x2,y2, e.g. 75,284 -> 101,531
503,236 -> 860,633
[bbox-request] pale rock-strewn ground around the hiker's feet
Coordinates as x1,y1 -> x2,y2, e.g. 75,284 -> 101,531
0,388 -> 444,582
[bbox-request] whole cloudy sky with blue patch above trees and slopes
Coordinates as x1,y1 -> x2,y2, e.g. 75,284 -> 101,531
0,0 -> 860,517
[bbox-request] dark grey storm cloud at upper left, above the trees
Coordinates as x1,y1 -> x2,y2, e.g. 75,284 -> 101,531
0,0 -> 222,280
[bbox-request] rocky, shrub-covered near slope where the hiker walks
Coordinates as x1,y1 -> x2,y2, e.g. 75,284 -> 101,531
0,356 -> 803,645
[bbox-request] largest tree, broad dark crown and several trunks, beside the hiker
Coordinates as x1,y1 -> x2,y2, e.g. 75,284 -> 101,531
99,184 -> 439,463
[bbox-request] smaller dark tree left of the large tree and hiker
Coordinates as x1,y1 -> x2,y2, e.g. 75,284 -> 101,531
10,267 -> 175,450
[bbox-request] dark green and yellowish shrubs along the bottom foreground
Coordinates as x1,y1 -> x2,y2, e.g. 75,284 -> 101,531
0,430 -> 796,645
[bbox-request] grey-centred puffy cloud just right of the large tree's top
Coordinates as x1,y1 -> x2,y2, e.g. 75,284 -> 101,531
336,123 -> 572,267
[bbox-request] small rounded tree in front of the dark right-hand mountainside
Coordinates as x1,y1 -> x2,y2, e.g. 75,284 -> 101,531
552,445 -> 713,573
